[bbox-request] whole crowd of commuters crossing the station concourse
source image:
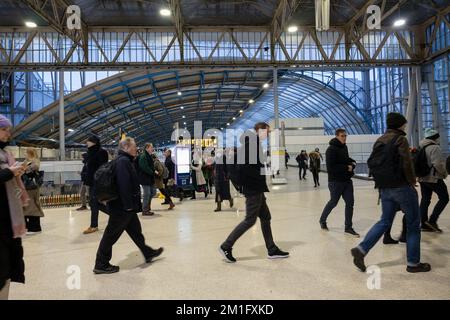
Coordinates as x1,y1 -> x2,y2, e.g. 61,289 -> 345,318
0,113 -> 449,299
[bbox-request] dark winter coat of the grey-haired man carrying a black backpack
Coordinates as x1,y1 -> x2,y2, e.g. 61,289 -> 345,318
108,151 -> 142,215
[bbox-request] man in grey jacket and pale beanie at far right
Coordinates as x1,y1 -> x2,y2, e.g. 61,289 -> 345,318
419,128 -> 449,232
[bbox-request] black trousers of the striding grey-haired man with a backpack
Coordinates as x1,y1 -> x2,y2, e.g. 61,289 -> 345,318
95,212 -> 154,269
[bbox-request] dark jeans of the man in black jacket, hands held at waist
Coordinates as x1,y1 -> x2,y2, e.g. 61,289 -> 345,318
320,180 -> 355,229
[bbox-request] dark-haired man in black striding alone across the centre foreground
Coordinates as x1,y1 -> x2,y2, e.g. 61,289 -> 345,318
219,122 -> 289,263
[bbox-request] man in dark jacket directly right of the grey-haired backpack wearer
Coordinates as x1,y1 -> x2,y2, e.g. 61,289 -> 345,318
137,143 -> 156,216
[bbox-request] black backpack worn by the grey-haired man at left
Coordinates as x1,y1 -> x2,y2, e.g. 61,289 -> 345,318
94,160 -> 119,204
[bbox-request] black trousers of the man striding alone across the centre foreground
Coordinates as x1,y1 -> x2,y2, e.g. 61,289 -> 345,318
223,193 -> 278,253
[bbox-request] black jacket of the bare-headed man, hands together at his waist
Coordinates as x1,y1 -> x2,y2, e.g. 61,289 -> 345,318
325,138 -> 356,182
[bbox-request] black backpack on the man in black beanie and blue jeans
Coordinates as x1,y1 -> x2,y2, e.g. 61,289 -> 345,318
367,136 -> 401,188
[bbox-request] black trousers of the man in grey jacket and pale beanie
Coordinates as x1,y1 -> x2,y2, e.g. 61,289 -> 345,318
420,179 -> 449,224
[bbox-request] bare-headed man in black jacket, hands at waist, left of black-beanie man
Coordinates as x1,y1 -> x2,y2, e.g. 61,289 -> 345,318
320,129 -> 359,238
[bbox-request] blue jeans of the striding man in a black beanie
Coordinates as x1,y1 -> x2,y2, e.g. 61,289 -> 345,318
358,186 -> 420,266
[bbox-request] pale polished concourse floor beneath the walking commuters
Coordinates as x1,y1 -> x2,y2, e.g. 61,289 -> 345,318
10,172 -> 450,299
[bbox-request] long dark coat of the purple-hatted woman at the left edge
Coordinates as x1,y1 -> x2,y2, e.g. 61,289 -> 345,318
0,144 -> 25,289
